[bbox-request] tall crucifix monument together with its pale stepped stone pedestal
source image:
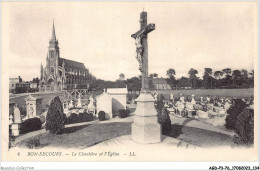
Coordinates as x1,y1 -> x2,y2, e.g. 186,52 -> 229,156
131,11 -> 162,143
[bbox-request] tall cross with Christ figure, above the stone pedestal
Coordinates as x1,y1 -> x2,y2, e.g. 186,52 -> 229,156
131,11 -> 155,92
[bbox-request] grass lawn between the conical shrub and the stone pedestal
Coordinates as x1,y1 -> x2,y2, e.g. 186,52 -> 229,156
17,122 -> 131,149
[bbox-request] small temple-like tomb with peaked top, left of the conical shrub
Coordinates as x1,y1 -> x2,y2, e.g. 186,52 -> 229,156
25,94 -> 43,118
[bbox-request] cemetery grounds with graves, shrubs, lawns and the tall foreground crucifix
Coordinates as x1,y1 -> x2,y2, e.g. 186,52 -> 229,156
9,11 -> 254,149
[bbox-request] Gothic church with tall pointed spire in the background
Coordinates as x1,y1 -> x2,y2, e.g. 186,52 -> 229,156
39,23 -> 90,91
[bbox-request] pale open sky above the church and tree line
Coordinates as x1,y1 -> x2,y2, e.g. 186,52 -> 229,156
6,2 -> 257,81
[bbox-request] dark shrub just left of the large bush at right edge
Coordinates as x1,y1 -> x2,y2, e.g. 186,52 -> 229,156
225,99 -> 248,130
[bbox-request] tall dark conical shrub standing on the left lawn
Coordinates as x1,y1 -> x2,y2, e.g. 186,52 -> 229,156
45,96 -> 66,134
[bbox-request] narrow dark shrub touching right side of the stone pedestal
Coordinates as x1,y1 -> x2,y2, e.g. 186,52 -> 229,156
157,107 -> 172,135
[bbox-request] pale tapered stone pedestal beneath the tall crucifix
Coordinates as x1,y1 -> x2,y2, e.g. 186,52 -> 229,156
132,93 -> 162,144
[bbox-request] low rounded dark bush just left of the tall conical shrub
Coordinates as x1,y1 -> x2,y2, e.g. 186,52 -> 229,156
20,118 -> 42,134
